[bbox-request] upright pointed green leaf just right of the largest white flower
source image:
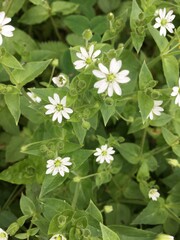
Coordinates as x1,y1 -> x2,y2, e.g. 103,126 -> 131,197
139,61 -> 153,90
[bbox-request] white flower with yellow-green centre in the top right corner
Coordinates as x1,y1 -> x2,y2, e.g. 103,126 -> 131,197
154,8 -> 175,36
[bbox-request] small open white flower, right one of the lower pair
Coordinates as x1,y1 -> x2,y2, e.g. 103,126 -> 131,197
94,144 -> 115,163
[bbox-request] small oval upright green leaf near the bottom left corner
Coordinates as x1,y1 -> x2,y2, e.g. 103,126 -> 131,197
20,194 -> 36,216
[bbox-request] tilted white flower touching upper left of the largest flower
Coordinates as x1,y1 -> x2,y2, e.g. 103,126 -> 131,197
73,45 -> 101,70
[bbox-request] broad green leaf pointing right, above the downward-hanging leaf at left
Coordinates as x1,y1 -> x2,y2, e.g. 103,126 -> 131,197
12,60 -> 51,87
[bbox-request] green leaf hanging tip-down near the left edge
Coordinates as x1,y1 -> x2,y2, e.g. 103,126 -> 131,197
4,93 -> 21,125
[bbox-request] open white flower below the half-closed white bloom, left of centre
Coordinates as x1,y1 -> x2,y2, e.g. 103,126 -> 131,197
45,93 -> 73,123
